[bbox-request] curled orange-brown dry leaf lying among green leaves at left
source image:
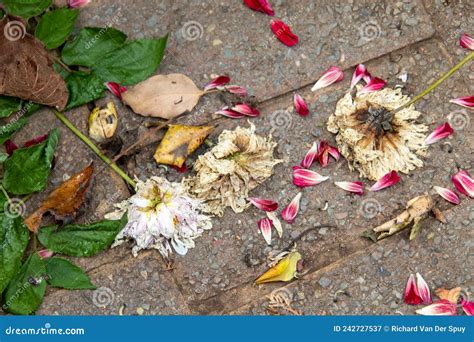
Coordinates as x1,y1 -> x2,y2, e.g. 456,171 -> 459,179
25,165 -> 94,233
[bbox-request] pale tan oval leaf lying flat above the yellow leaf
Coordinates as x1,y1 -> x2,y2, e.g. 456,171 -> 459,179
122,74 -> 204,119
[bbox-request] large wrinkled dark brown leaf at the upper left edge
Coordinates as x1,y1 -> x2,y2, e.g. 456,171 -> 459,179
0,16 -> 68,110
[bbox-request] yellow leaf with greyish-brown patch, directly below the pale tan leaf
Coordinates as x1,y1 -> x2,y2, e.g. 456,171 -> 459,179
154,125 -> 214,167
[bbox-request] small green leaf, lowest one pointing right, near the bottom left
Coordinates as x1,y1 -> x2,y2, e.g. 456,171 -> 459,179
45,257 -> 96,290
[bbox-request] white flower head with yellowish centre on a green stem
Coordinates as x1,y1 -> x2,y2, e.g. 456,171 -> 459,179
106,177 -> 212,256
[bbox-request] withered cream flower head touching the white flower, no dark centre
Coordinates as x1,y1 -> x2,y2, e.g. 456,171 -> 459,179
184,124 -> 282,216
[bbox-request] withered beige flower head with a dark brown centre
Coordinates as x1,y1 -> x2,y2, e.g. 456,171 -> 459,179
327,86 -> 428,180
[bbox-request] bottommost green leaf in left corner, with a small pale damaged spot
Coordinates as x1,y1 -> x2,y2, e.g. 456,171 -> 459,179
4,253 -> 47,315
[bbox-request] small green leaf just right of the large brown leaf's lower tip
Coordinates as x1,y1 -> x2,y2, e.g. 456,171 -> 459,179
66,71 -> 105,109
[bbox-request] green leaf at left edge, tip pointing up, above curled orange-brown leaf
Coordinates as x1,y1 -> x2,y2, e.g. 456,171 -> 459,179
3,128 -> 59,195
